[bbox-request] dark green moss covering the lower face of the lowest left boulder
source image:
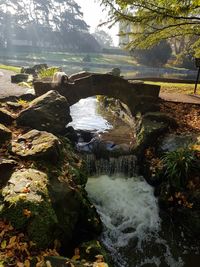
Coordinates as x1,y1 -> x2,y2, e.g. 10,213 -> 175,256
0,197 -> 58,248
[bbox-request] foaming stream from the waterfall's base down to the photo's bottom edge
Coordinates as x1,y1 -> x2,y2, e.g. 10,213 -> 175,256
86,175 -> 186,267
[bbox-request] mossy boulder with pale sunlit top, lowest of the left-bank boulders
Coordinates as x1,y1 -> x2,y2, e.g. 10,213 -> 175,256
0,169 -> 58,247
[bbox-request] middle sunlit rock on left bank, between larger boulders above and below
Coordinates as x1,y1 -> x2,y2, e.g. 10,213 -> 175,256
12,130 -> 61,161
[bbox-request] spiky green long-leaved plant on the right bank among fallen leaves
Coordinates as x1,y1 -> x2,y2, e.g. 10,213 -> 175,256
162,148 -> 199,188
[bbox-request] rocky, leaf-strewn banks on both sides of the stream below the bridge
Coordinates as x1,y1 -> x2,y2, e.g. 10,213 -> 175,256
0,82 -> 200,267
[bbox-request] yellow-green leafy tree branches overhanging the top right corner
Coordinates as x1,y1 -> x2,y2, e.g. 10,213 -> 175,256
100,0 -> 200,56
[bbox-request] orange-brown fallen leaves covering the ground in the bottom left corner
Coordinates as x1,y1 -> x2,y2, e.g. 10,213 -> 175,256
0,220 -> 108,267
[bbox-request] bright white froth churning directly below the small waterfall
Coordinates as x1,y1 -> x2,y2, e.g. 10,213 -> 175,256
86,175 -> 160,248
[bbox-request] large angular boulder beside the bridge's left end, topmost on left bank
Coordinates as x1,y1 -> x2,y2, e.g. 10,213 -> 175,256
17,91 -> 72,133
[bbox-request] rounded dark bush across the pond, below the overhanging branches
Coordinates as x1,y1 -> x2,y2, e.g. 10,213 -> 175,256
131,41 -> 172,67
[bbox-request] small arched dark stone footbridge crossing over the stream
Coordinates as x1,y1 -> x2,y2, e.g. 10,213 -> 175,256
34,74 -> 160,115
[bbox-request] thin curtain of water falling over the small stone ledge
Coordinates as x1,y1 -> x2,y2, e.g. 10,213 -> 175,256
82,154 -> 137,177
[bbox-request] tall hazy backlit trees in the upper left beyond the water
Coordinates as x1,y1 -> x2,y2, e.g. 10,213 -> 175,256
0,0 -> 99,51
